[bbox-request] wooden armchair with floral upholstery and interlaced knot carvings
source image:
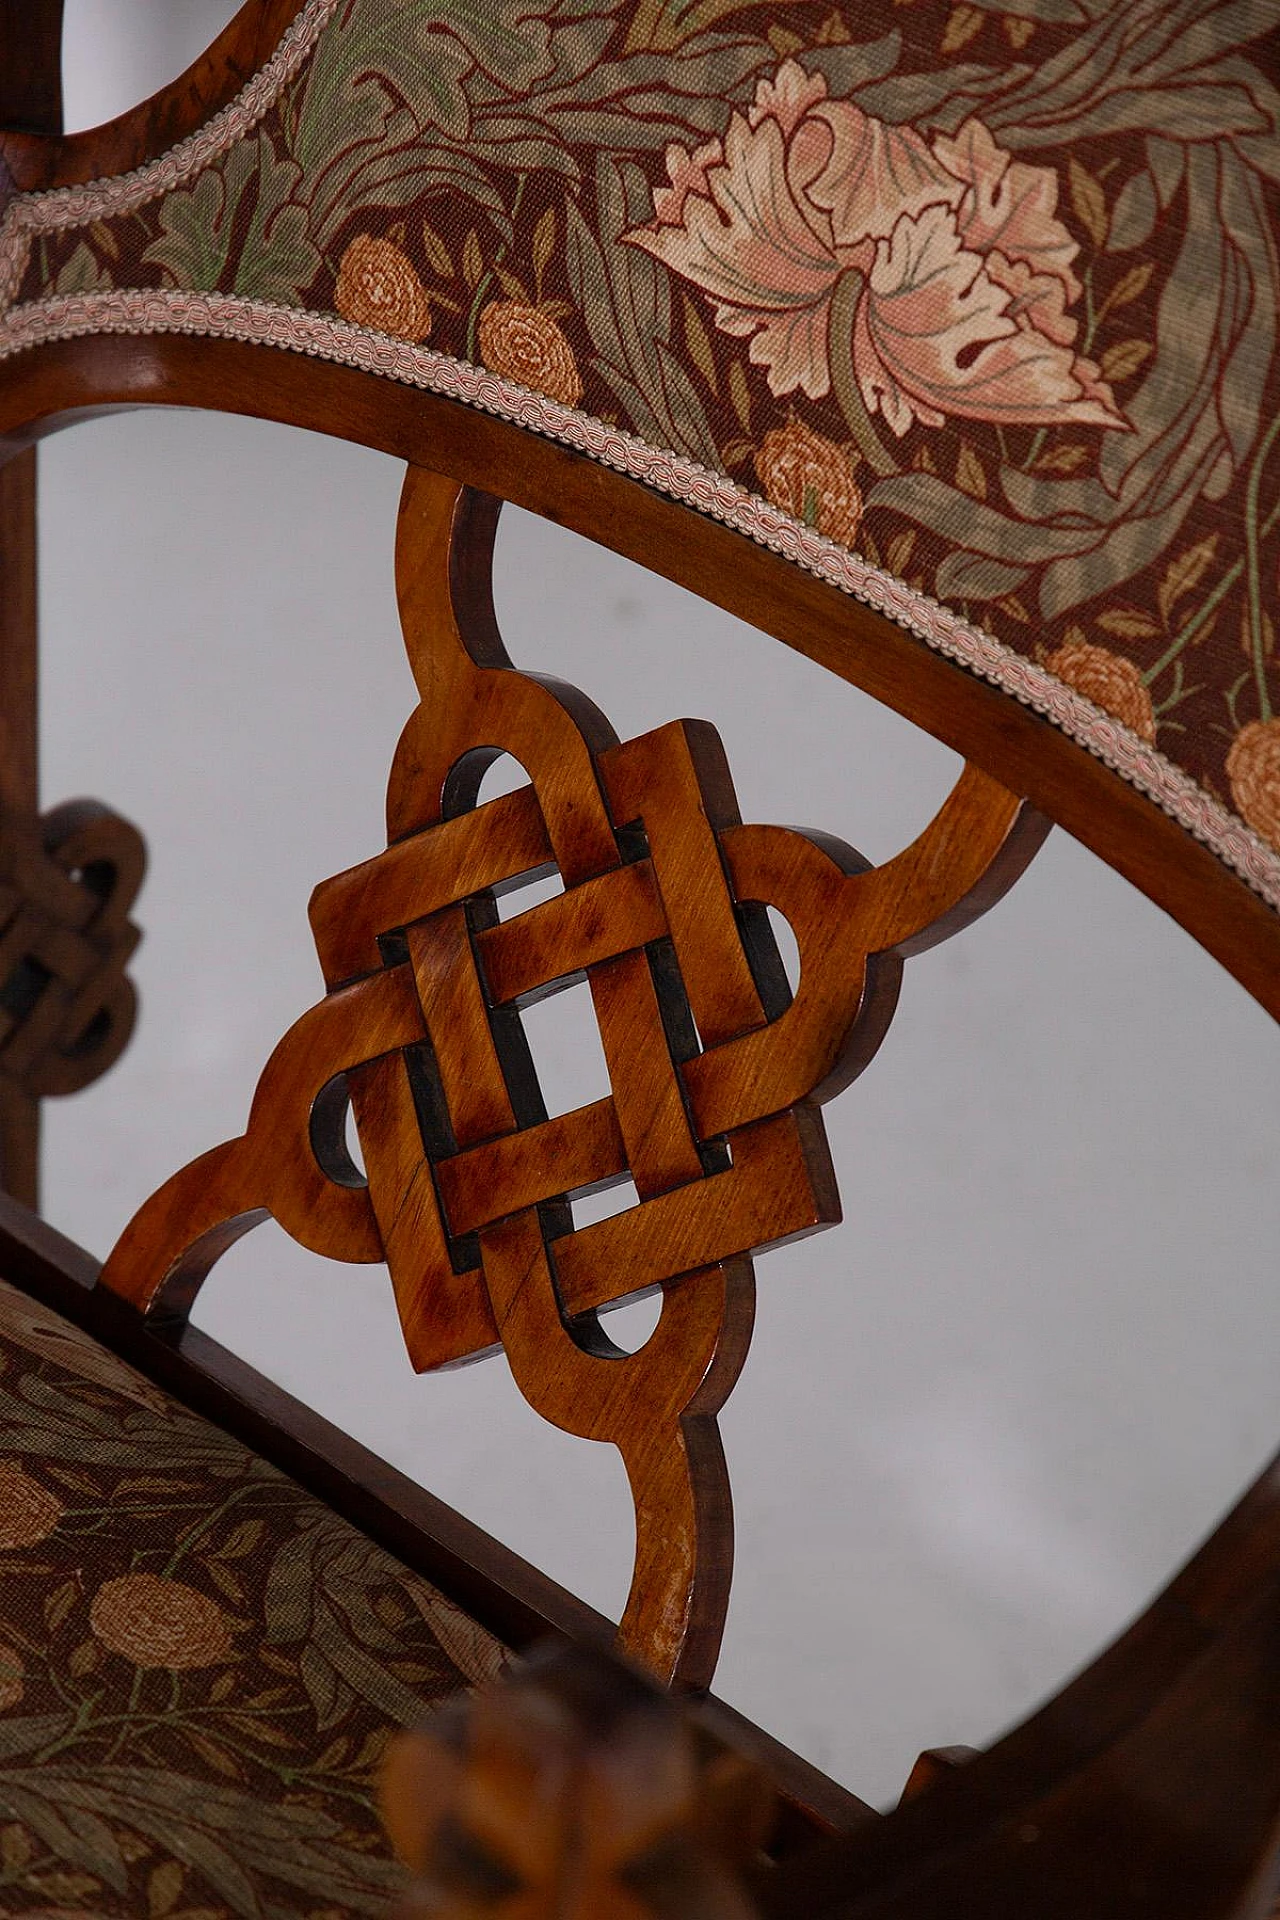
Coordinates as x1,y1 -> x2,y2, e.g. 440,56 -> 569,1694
0,0 -> 1280,1920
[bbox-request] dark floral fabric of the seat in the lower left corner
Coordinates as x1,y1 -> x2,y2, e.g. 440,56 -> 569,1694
0,1283 -> 503,1920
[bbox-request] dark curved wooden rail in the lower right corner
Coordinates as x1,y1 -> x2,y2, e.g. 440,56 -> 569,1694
766,1459 -> 1280,1920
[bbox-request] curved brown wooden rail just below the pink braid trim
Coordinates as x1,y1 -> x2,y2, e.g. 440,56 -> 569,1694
0,338 -> 1280,1018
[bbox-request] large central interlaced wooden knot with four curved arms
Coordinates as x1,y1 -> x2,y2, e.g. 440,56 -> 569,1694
104,468 -> 1048,1686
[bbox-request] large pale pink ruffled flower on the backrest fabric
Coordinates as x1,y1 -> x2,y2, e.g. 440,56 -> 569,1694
626,60 -> 1128,434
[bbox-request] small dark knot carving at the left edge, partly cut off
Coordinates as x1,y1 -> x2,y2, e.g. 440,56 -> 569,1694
0,801 -> 146,1098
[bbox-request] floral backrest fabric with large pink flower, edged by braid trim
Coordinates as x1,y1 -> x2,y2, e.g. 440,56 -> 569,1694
0,0 -> 1280,908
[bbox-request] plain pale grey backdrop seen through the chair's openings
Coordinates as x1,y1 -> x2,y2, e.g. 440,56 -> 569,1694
40,0 -> 1280,1799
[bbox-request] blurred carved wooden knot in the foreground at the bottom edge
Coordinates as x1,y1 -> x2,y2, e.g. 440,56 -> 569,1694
382,1647 -> 773,1920
